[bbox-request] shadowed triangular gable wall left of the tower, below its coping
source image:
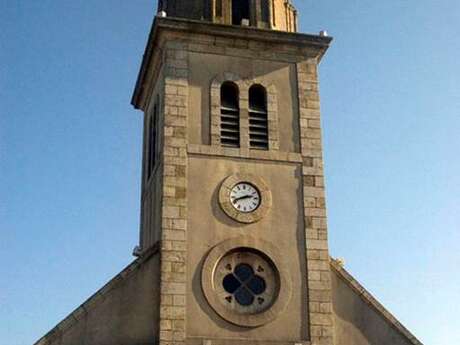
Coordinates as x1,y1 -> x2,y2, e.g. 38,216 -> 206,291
37,255 -> 159,345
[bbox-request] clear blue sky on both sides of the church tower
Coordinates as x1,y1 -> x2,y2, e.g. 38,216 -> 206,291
0,0 -> 460,345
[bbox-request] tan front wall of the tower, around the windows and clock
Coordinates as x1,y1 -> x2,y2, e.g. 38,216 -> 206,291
135,19 -> 333,345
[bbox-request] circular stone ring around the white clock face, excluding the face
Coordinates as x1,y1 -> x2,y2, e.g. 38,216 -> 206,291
219,173 -> 272,224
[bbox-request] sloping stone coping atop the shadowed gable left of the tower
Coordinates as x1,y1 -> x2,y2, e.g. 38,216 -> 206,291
34,242 -> 160,345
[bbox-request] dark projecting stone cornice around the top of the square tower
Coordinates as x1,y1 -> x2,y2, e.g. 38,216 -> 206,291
131,17 -> 332,109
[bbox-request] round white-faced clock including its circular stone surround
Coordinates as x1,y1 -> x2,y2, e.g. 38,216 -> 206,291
219,173 -> 272,224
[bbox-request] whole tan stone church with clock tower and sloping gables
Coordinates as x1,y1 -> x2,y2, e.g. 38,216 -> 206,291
36,0 -> 421,345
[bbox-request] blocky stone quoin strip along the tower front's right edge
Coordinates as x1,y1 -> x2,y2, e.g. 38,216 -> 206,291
297,59 -> 334,345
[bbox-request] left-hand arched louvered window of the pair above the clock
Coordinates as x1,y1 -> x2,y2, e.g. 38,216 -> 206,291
220,82 -> 240,147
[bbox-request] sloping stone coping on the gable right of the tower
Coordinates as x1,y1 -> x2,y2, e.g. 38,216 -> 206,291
330,258 -> 423,345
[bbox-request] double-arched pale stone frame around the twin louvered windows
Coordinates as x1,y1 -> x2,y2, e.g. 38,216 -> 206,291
210,72 -> 280,151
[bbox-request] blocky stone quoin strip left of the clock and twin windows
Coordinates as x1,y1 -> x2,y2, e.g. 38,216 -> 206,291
159,41 -> 188,345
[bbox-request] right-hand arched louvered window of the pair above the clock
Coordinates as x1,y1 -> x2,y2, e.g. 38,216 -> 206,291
249,85 -> 269,150
